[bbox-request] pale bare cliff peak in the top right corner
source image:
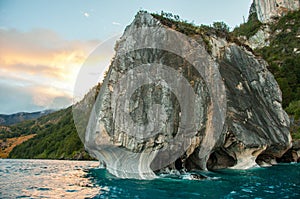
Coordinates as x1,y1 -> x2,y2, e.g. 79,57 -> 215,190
253,0 -> 300,23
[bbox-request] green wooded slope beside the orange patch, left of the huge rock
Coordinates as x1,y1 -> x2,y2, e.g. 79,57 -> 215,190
9,107 -> 90,159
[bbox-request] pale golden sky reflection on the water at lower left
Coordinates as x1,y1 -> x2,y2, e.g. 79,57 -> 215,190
0,159 -> 101,198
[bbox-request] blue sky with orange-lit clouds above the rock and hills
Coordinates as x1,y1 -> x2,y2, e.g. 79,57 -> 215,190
0,0 -> 252,114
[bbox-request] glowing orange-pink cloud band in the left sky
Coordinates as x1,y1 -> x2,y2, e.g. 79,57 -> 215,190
0,29 -> 99,81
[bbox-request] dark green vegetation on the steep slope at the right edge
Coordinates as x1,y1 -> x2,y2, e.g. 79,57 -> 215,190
258,11 -> 300,107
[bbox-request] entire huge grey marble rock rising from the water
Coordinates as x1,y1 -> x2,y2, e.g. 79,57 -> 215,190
79,12 -> 291,178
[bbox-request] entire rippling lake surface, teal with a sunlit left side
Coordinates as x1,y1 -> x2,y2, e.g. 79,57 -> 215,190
0,159 -> 300,199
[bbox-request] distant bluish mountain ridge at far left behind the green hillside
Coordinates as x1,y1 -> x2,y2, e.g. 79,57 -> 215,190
0,110 -> 54,125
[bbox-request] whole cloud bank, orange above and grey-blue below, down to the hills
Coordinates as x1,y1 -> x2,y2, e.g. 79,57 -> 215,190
0,29 -> 104,113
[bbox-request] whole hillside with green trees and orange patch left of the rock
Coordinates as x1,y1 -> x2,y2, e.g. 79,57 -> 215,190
4,84 -> 100,160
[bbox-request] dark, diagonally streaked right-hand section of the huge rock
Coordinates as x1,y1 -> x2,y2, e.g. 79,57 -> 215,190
210,38 -> 291,169
